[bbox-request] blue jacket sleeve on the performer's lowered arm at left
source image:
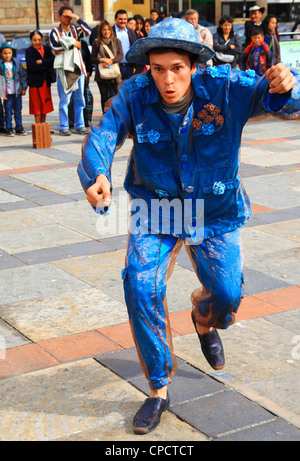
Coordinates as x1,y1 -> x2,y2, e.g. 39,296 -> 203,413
78,86 -> 131,191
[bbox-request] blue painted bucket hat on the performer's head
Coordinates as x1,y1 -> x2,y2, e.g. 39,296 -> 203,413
126,18 -> 215,65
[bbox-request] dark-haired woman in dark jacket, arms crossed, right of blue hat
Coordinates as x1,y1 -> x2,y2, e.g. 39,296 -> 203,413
213,16 -> 242,69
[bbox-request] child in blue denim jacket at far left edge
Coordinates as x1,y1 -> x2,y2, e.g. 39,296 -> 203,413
0,43 -> 27,136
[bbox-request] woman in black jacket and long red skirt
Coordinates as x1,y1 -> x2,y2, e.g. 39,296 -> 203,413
25,31 -> 54,123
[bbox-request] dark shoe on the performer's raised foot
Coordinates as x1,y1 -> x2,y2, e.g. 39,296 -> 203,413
192,314 -> 225,370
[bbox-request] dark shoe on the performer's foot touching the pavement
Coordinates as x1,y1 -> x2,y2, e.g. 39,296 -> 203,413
133,392 -> 170,434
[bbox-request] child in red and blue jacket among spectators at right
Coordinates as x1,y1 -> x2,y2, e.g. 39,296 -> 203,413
240,28 -> 272,76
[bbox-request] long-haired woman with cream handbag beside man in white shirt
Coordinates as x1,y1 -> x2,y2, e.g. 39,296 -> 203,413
91,20 -> 123,114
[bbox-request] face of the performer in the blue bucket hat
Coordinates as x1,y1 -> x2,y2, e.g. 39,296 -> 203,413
149,52 -> 196,104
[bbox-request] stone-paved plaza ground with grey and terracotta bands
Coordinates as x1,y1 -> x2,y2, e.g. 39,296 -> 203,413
0,82 -> 300,443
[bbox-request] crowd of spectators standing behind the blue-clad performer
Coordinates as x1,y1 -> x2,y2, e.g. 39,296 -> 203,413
0,5 -> 300,136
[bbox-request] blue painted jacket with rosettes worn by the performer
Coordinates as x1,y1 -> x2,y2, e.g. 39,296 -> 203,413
78,65 -> 300,240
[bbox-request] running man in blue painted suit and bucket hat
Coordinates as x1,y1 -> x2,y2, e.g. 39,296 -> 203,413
78,19 -> 300,434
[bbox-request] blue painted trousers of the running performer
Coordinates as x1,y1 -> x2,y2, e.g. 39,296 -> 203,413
123,230 -> 244,389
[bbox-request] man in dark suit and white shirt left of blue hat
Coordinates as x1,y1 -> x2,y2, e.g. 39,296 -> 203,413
112,10 -> 138,80
